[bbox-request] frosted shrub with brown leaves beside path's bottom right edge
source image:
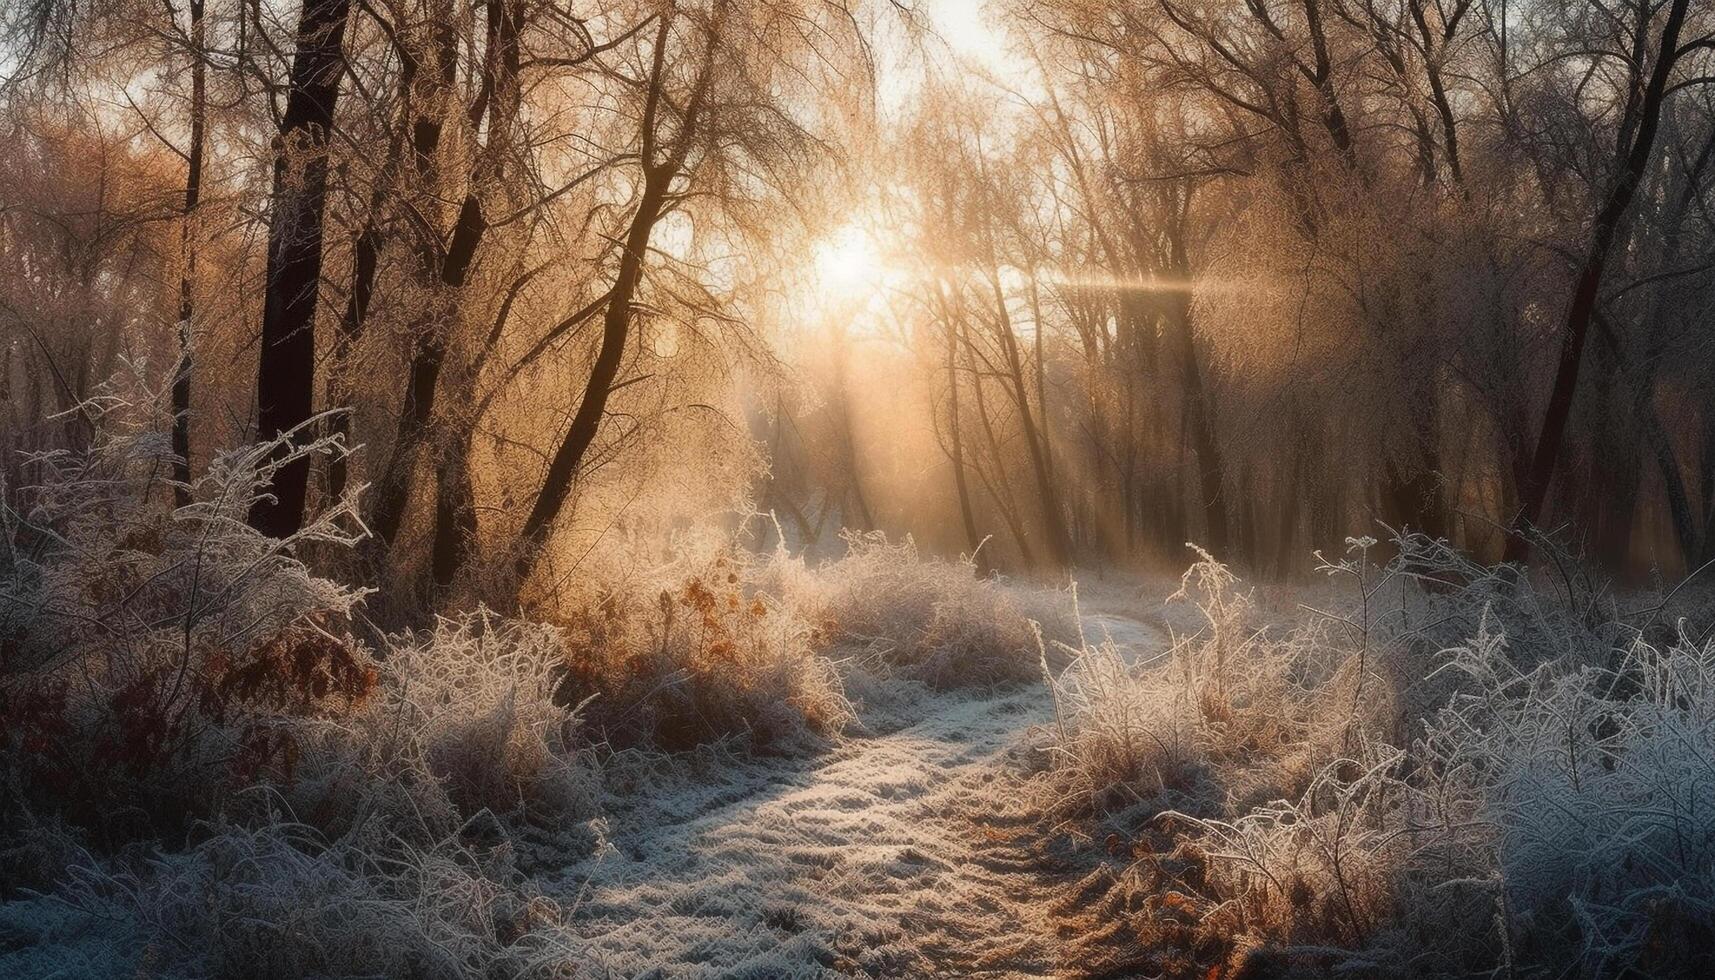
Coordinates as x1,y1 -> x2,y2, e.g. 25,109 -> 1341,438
1159,738 -> 1494,973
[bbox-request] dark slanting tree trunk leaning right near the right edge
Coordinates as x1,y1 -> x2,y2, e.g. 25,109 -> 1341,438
1506,0 -> 1689,561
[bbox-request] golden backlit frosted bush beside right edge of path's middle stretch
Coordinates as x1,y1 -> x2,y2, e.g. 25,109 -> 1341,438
1043,547 -> 1365,814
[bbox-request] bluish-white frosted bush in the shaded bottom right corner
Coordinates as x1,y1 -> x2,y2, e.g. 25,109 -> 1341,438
1420,625 -> 1715,977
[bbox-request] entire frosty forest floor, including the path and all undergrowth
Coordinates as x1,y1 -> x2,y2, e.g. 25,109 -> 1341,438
0,535 -> 1715,980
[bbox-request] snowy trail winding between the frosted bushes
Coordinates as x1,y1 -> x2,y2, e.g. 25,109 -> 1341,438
556,614 -> 1159,978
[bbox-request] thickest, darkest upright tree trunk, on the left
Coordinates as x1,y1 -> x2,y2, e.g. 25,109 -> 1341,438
250,0 -> 352,537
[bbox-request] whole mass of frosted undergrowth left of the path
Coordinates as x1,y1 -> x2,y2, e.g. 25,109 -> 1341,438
0,390 -> 1070,977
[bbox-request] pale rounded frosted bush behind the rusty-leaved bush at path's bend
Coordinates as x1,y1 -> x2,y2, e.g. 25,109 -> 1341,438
775,532 -> 1074,687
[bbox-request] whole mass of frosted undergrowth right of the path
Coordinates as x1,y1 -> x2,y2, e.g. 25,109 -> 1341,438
1046,537 -> 1715,977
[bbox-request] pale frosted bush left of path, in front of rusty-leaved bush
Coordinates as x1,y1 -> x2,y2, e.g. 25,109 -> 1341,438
281,609 -> 599,843
